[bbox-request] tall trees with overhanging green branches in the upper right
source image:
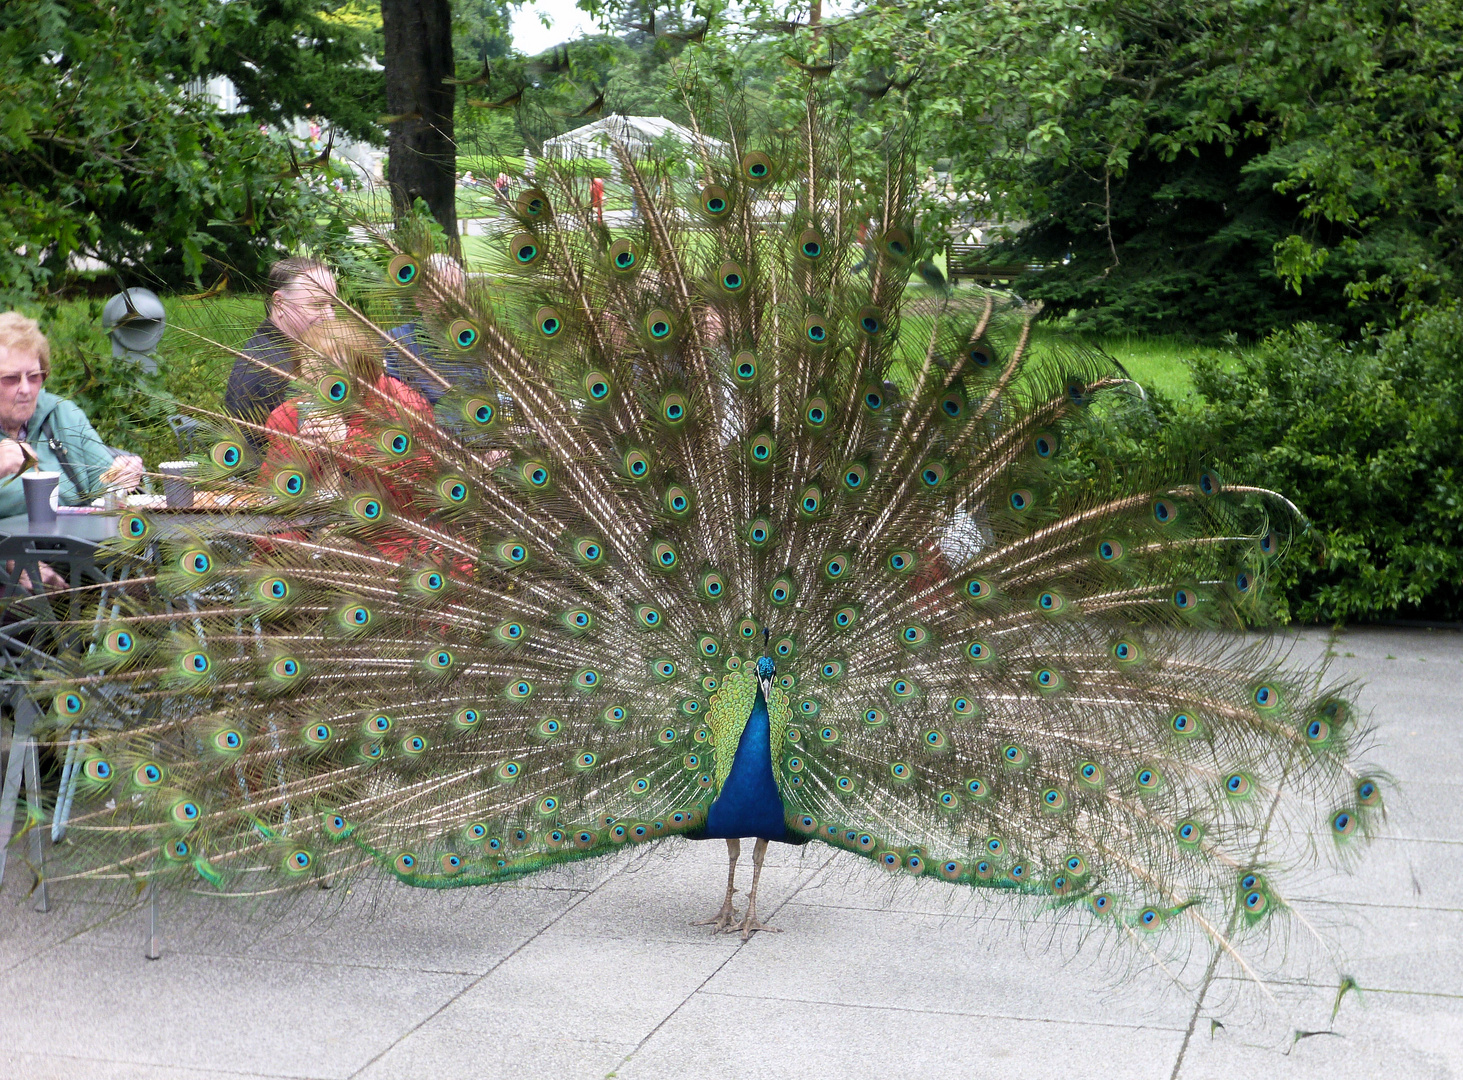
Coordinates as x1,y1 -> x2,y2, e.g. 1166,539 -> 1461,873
801,0 -> 1463,334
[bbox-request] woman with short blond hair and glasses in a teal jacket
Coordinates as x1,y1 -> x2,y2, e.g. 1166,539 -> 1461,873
0,312 -> 143,518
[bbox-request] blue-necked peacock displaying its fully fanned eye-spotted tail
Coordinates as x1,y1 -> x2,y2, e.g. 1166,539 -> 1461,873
14,86 -> 1384,995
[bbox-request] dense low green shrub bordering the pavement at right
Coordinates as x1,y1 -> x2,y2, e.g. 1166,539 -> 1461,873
1069,309 -> 1463,622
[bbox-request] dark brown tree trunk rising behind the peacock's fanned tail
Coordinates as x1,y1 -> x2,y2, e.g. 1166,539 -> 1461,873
380,0 -> 456,240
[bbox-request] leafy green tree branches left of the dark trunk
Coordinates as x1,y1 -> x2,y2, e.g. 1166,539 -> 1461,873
0,0 -> 359,306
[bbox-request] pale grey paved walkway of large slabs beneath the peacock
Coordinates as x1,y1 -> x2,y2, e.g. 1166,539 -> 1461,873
0,629 -> 1463,1080
